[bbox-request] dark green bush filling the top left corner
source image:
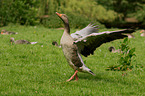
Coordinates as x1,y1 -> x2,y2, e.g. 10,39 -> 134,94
0,0 -> 37,25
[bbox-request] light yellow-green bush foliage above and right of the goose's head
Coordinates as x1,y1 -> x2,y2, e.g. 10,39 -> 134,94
60,0 -> 118,23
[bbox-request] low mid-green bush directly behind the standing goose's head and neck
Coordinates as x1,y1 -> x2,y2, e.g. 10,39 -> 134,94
42,13 -> 105,28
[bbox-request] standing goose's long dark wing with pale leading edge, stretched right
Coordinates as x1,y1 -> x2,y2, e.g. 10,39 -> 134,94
74,29 -> 135,57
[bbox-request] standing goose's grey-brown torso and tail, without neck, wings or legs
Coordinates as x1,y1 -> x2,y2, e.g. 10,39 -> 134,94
60,29 -> 94,75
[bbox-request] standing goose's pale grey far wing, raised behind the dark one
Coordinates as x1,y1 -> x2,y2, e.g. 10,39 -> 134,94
71,24 -> 98,41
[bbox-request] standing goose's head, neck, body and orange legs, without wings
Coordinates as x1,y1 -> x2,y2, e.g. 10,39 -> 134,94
56,13 -> 95,81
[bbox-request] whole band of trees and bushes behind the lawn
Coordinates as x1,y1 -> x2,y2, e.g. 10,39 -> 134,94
0,0 -> 145,28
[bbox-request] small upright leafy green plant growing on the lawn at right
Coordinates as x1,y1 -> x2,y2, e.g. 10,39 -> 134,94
107,38 -> 136,71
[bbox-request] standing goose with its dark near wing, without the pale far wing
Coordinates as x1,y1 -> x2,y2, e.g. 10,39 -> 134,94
56,12 -> 134,81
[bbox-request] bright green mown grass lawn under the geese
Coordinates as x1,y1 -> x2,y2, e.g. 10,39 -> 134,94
0,25 -> 145,96
